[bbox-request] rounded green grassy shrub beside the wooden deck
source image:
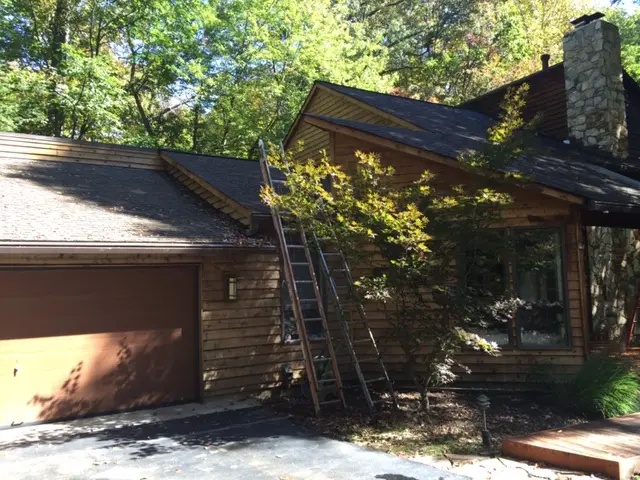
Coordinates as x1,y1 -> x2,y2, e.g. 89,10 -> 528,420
555,356 -> 640,418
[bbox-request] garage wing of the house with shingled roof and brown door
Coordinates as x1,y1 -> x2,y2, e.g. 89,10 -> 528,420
0,133 -> 297,425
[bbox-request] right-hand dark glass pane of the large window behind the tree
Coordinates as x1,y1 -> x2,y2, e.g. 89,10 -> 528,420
514,229 -> 568,346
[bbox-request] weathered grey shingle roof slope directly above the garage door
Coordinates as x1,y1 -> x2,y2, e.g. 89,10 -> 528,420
0,159 -> 255,244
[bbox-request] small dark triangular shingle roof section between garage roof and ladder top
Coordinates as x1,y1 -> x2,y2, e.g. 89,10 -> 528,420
164,151 -> 282,215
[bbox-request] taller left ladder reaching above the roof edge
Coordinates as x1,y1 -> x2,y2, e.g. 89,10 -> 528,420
259,140 -> 345,415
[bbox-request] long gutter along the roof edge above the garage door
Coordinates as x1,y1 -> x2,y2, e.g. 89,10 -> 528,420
0,242 -> 276,255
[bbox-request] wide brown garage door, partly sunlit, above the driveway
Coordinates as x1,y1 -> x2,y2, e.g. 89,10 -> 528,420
0,266 -> 198,425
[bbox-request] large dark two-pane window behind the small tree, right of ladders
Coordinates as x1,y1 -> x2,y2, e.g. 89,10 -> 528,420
459,228 -> 568,347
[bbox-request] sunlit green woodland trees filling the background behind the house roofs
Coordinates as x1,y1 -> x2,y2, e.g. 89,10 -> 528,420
0,0 -> 640,152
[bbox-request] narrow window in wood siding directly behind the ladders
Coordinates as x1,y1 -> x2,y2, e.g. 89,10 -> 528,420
280,232 -> 326,343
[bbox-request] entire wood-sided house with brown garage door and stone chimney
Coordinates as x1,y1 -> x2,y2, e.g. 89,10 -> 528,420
0,11 -> 640,425
